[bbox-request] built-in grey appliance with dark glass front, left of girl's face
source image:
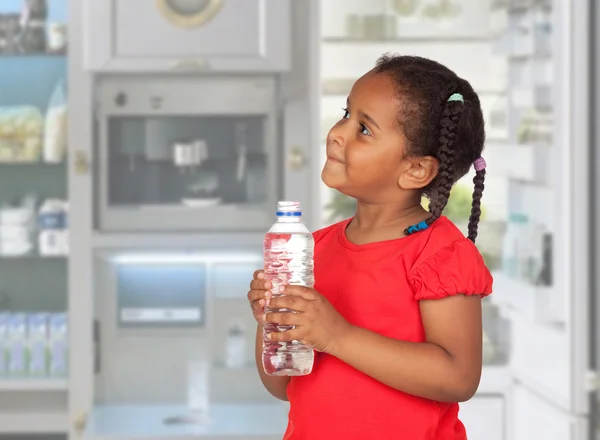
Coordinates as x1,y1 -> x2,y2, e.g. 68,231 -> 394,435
96,76 -> 281,231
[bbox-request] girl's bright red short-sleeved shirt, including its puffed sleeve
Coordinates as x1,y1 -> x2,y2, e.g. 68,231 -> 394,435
284,217 -> 492,440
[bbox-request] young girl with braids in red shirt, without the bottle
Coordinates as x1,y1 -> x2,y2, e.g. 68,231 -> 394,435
248,56 -> 492,440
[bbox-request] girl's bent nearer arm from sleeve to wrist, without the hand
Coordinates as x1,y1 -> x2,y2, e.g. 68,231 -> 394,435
328,295 -> 482,402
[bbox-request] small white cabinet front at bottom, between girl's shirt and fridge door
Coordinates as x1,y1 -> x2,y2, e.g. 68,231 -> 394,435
458,396 -> 508,440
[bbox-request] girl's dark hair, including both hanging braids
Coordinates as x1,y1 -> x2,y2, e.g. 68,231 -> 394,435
373,54 -> 485,243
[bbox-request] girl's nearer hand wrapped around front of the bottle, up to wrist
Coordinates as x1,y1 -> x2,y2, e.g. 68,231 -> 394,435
265,285 -> 352,353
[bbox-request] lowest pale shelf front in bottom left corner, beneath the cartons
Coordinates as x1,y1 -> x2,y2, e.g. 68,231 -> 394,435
0,411 -> 68,434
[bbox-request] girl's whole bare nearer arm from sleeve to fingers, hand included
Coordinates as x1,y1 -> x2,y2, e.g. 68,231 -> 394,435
266,286 -> 482,402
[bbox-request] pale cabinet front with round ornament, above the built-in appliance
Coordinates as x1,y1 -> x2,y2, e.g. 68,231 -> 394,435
83,0 -> 291,72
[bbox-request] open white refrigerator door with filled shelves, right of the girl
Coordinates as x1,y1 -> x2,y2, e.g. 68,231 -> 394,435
493,0 -> 600,440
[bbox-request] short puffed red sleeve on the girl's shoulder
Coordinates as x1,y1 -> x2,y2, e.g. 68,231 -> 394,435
408,238 -> 493,300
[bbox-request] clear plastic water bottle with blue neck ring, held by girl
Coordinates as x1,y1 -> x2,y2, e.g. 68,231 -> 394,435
262,202 -> 315,376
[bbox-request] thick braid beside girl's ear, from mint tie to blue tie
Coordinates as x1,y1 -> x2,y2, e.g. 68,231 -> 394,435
404,93 -> 465,235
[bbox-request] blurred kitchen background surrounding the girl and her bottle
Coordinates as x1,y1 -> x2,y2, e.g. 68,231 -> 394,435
0,0 -> 600,440
